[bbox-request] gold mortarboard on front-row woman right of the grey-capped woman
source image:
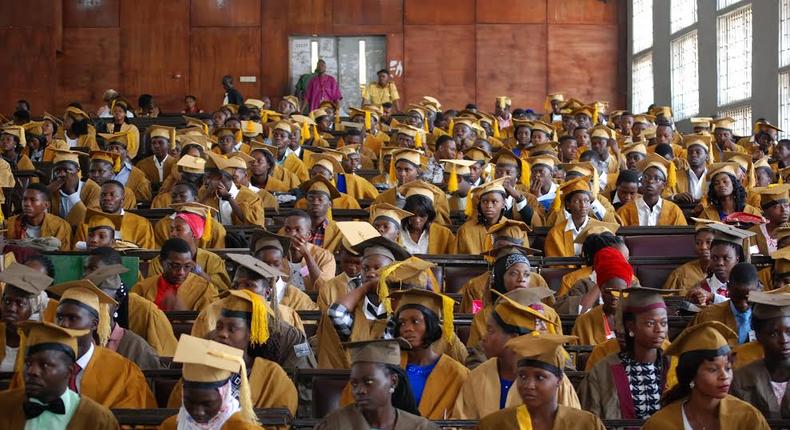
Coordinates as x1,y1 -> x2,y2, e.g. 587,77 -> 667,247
505,332 -> 579,373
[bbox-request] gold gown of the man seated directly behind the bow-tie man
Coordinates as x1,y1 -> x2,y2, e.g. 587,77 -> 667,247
10,345 -> 156,409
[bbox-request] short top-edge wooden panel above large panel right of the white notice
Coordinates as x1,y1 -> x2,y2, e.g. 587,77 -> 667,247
403,0 -> 474,25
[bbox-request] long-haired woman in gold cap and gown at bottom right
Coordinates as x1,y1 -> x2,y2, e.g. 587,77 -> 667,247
642,321 -> 770,430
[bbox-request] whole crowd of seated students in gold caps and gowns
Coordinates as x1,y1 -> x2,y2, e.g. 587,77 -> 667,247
0,94 -> 790,430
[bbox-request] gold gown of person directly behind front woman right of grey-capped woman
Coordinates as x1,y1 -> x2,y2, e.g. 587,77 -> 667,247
452,357 -> 581,420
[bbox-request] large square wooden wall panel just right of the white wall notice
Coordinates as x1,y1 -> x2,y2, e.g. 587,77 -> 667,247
401,25 -> 475,107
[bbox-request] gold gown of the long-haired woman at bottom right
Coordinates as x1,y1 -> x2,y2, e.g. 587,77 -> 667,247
642,394 -> 770,430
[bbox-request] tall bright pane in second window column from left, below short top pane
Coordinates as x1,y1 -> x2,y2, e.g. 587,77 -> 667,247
671,30 -> 699,119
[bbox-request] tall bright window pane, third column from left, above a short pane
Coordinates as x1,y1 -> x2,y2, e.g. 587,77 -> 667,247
717,5 -> 752,106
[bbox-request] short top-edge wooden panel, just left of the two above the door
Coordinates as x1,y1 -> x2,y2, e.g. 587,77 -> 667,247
190,0 -> 261,27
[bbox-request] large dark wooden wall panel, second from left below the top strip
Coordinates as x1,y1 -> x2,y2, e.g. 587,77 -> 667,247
54,28 -> 120,113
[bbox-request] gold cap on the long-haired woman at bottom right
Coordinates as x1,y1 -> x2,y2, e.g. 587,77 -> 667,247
666,321 -> 738,360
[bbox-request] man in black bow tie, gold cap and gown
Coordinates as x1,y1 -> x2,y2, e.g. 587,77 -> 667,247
0,321 -> 119,430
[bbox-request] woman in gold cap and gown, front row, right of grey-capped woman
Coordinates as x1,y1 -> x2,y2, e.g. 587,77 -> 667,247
478,334 -> 605,430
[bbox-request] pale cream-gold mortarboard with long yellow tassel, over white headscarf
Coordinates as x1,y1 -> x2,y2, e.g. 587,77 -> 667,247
173,334 -> 258,424
